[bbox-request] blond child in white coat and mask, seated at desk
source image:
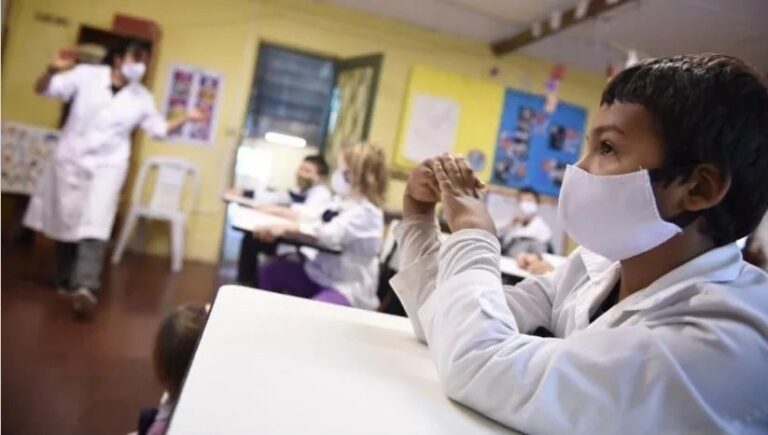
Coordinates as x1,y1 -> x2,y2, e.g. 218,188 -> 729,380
254,144 -> 387,310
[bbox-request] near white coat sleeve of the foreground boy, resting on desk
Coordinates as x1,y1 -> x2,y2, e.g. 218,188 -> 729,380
418,230 -> 760,434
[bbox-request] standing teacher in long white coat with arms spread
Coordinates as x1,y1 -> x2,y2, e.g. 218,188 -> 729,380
24,43 -> 206,314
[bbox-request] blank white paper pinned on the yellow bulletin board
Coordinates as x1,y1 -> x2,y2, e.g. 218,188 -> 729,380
405,93 -> 459,162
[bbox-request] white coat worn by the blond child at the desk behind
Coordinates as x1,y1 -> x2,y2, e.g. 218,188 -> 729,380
300,198 -> 384,310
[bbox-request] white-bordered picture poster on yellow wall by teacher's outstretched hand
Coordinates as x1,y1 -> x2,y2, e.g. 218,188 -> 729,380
164,65 -> 224,145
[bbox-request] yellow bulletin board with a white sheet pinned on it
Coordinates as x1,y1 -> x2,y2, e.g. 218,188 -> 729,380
394,66 -> 504,180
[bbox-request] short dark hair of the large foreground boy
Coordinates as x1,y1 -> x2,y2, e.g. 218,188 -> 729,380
600,54 -> 768,246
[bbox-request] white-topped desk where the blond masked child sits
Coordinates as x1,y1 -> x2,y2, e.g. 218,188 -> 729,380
230,204 -> 341,286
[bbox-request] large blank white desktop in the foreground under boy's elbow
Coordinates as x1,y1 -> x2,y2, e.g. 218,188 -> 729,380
168,286 -> 513,435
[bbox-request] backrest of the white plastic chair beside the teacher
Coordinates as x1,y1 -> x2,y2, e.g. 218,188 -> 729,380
132,157 -> 200,213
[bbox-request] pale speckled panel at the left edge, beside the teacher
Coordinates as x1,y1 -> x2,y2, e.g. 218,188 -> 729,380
2,121 -> 59,195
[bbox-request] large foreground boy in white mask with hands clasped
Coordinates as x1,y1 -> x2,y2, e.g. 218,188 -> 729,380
391,54 -> 768,434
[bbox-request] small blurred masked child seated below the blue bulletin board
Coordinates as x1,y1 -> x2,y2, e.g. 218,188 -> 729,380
499,187 -> 552,257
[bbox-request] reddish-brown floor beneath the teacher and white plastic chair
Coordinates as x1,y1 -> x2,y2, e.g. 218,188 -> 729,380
2,239 -> 228,435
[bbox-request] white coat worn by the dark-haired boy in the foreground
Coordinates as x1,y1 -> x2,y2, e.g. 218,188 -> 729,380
391,218 -> 768,434
